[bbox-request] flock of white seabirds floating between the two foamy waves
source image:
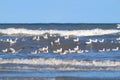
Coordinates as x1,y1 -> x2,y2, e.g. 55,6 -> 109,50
0,34 -> 120,54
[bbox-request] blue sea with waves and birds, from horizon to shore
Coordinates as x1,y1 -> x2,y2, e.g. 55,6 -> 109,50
0,23 -> 120,80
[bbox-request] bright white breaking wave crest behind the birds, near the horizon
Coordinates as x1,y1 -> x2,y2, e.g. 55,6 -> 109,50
0,28 -> 120,36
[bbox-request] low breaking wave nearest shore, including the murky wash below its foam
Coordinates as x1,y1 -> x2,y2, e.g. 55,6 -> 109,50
0,58 -> 120,71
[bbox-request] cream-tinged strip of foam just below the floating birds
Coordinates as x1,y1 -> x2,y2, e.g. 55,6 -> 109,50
0,58 -> 120,66
